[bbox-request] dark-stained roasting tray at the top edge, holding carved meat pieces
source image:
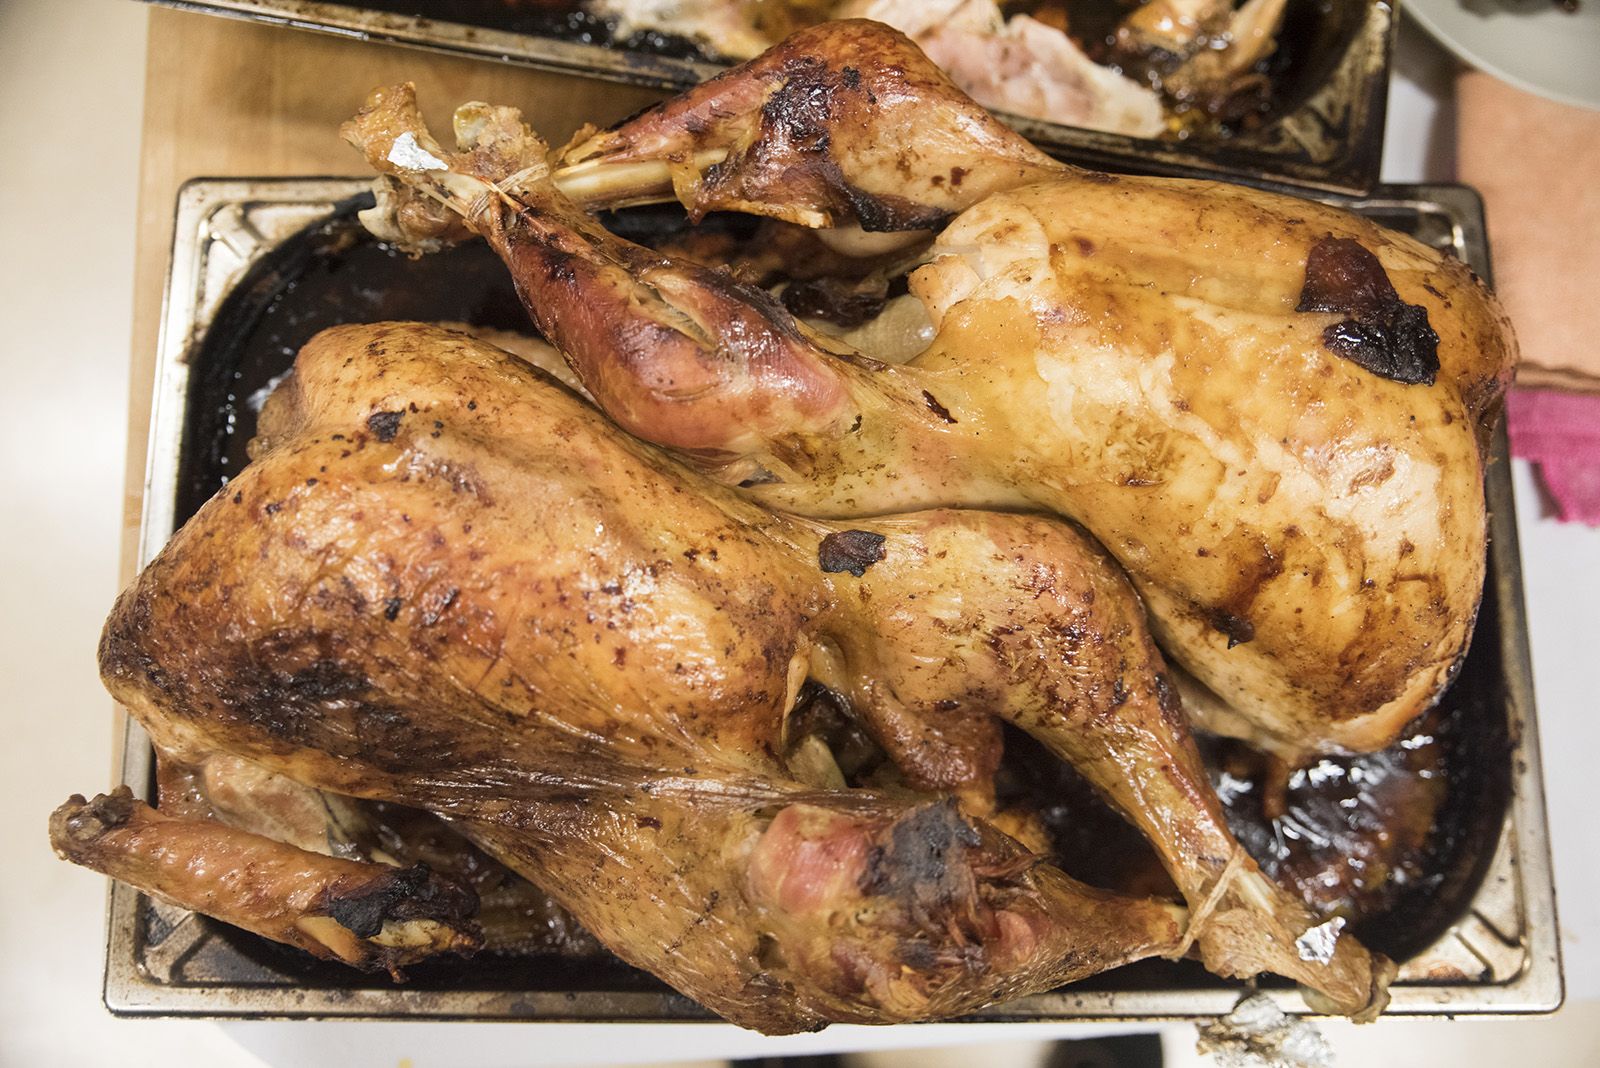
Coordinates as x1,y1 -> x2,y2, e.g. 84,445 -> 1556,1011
147,0 -> 1397,193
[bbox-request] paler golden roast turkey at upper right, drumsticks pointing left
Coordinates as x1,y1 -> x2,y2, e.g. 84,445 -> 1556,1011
346,21 -> 1515,761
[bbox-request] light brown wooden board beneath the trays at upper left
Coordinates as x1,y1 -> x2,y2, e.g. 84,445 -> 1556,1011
122,8 -> 662,582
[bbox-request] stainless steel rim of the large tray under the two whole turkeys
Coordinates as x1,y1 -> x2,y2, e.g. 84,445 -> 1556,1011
104,179 -> 1562,1022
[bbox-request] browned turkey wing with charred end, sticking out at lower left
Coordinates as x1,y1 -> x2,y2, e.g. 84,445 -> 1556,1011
50,787 -> 483,978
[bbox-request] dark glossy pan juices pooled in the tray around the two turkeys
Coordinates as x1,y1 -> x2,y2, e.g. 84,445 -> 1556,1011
172,197 -> 1514,991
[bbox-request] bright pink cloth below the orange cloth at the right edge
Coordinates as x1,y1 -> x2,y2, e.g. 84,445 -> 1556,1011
1506,390 -> 1600,526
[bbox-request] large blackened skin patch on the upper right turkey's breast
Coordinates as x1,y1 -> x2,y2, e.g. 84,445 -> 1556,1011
1294,235 -> 1438,385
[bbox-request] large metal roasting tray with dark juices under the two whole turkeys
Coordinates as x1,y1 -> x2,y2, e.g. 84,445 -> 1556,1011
106,179 -> 1562,1020
